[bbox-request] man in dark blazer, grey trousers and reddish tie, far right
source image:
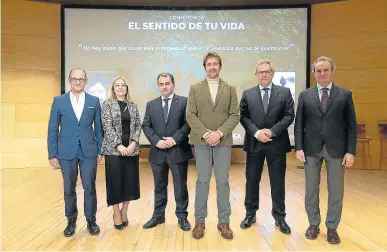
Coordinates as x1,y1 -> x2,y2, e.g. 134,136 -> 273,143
295,56 -> 357,244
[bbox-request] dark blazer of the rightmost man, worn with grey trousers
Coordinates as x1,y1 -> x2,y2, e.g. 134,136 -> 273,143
295,84 -> 357,158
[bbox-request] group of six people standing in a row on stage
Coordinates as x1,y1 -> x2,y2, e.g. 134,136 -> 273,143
48,52 -> 357,244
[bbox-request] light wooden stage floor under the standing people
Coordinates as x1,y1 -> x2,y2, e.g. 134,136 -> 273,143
1,163 -> 387,251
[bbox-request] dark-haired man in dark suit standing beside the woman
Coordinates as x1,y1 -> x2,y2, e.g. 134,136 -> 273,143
142,73 -> 193,231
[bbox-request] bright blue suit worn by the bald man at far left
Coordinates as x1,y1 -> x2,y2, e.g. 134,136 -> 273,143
47,92 -> 103,220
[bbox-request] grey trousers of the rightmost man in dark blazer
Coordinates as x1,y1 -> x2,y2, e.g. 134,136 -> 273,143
305,145 -> 344,229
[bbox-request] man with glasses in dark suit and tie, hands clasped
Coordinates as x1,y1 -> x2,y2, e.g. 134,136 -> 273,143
240,60 -> 294,234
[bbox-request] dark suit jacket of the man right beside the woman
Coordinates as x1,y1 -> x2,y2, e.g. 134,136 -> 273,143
142,94 -> 193,164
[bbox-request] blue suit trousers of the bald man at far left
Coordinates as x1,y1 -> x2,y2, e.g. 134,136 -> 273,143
59,144 -> 97,220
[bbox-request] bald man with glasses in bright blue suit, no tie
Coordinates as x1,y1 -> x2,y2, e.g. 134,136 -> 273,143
47,68 -> 103,237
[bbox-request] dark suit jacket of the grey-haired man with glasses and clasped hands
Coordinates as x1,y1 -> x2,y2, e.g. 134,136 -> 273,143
240,84 -> 294,155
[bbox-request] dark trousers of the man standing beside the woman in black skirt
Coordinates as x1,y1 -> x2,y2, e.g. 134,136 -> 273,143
151,158 -> 188,218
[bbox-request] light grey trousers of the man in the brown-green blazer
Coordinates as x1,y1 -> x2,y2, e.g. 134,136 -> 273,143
195,145 -> 231,223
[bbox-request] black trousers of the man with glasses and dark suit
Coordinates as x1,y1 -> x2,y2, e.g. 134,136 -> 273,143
245,150 -> 286,220
